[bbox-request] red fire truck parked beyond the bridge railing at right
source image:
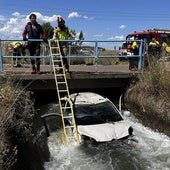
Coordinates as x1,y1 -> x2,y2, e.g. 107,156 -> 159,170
119,28 -> 170,59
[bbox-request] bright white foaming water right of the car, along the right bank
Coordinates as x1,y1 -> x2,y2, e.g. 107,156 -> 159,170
125,115 -> 170,170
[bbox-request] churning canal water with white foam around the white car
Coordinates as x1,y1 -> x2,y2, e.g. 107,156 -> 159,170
36,99 -> 170,170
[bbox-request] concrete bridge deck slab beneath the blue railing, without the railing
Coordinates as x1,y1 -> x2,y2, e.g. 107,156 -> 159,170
3,62 -> 138,91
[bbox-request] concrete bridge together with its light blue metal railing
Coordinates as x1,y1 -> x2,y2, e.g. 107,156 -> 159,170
0,40 -> 143,90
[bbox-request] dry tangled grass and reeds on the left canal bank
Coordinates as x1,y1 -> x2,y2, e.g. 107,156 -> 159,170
0,75 -> 34,170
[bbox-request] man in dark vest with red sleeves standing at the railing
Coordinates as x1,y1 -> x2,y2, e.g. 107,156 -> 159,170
22,14 -> 47,74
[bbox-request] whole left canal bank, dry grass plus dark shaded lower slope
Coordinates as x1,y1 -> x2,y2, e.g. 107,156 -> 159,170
0,76 -> 50,170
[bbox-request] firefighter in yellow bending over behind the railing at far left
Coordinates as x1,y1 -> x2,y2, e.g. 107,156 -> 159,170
8,41 -> 25,67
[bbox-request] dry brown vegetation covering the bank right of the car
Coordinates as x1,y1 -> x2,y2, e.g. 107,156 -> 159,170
125,62 -> 170,136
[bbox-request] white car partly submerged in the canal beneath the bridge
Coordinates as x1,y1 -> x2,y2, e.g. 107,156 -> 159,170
67,92 -> 133,142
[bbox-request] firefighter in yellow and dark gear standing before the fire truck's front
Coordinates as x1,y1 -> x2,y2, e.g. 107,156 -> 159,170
129,37 -> 139,71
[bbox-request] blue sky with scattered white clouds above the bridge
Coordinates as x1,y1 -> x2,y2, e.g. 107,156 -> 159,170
0,0 -> 170,40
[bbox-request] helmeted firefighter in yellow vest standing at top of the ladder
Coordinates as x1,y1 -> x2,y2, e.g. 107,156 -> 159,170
53,17 -> 75,71
